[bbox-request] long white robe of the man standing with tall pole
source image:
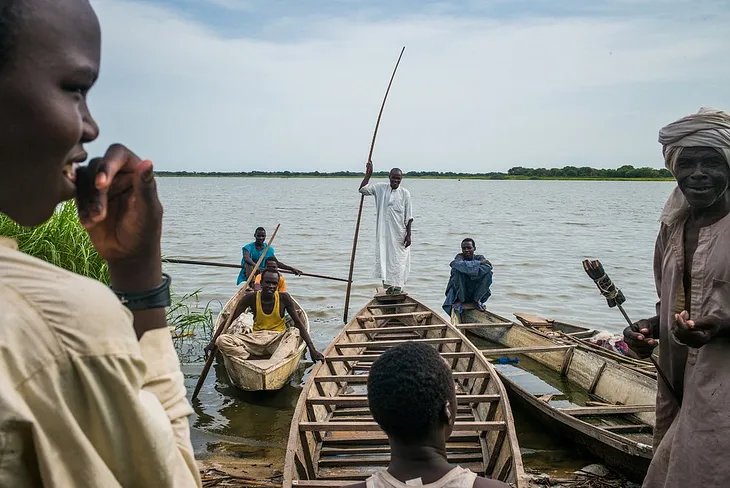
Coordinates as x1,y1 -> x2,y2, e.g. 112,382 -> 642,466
360,183 -> 413,287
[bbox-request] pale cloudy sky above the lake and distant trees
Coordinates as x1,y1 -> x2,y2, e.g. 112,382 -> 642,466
90,0 -> 730,172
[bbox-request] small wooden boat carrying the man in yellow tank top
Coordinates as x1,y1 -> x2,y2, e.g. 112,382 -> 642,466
213,288 -> 309,391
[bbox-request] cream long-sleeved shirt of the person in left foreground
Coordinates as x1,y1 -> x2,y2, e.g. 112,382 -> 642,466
0,239 -> 200,488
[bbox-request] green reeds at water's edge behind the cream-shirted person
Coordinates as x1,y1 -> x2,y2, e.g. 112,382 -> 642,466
0,201 -> 213,356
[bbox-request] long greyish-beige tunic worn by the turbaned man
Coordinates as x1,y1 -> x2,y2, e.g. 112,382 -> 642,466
644,214 -> 730,488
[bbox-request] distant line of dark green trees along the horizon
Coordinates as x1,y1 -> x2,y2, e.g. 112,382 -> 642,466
156,165 -> 672,180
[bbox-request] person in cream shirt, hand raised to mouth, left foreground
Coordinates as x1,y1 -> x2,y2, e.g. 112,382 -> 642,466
0,0 -> 200,488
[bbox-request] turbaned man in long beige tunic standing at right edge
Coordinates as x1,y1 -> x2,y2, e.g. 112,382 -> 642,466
624,108 -> 730,488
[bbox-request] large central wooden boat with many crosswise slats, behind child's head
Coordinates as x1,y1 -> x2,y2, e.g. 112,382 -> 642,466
284,294 -> 527,488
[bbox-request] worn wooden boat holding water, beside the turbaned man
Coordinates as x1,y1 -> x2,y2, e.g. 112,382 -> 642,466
451,309 -> 657,482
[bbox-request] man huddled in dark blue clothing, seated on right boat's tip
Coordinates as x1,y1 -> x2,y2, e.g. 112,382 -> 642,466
443,237 -> 492,315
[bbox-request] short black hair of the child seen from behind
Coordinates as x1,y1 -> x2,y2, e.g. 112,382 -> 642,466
368,342 -> 454,444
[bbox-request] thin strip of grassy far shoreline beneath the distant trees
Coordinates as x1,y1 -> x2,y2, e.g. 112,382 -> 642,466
155,171 -> 675,181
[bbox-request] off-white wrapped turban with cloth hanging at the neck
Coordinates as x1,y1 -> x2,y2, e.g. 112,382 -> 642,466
659,107 -> 730,225
